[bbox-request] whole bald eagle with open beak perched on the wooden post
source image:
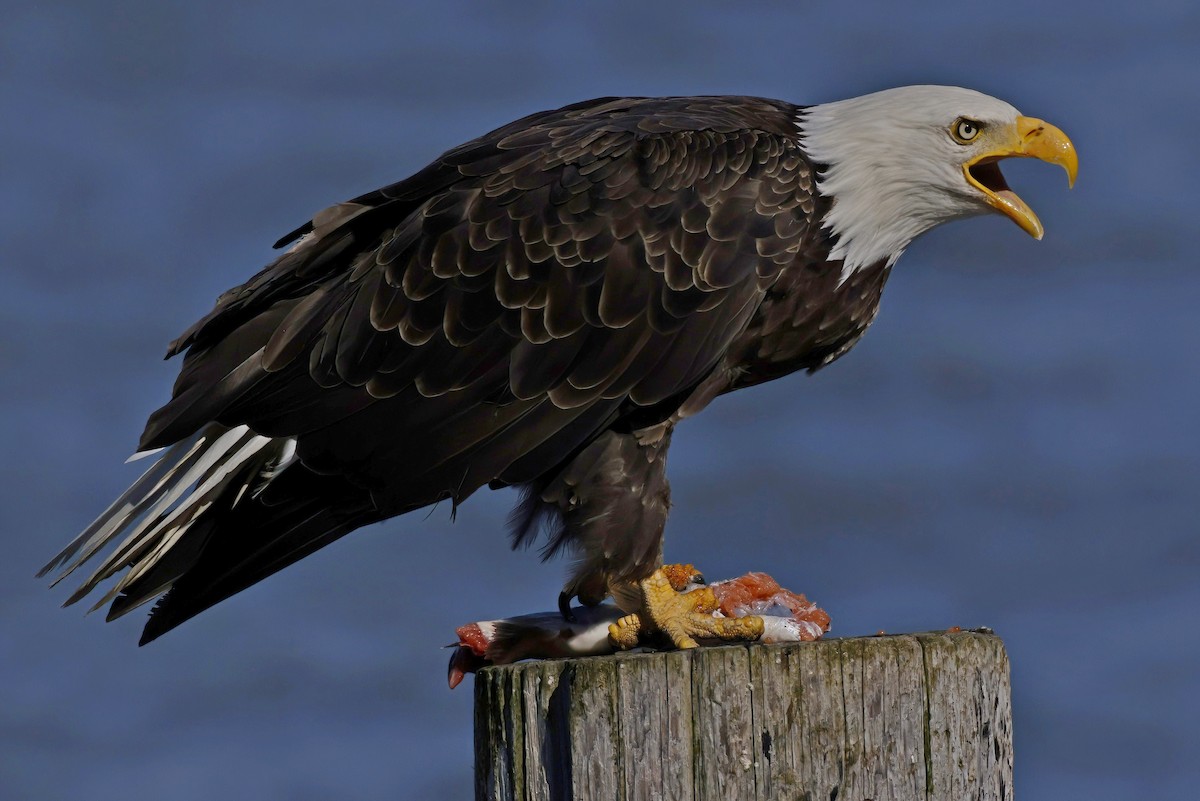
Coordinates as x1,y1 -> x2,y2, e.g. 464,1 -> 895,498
42,86 -> 1076,648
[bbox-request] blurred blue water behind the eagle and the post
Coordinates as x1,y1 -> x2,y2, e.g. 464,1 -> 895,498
0,0 -> 1200,801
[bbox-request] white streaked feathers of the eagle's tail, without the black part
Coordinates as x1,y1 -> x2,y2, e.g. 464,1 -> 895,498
38,423 -> 295,614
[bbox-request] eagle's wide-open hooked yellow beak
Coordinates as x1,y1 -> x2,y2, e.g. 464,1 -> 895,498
962,116 -> 1079,239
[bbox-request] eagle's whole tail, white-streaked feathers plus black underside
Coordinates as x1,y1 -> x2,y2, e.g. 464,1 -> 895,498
38,423 -> 370,642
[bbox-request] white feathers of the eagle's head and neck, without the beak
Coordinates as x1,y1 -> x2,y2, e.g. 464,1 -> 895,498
797,86 -> 1019,281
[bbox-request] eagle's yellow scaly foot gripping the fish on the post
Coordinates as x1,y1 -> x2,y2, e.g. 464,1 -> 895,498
608,565 -> 763,650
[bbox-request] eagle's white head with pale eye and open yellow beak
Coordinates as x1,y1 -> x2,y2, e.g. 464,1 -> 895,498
798,81 -> 1079,277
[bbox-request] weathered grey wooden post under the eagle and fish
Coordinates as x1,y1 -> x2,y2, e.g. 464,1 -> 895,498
475,632 -> 1013,801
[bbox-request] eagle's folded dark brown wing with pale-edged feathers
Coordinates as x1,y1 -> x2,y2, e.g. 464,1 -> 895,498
142,98 -> 814,513
